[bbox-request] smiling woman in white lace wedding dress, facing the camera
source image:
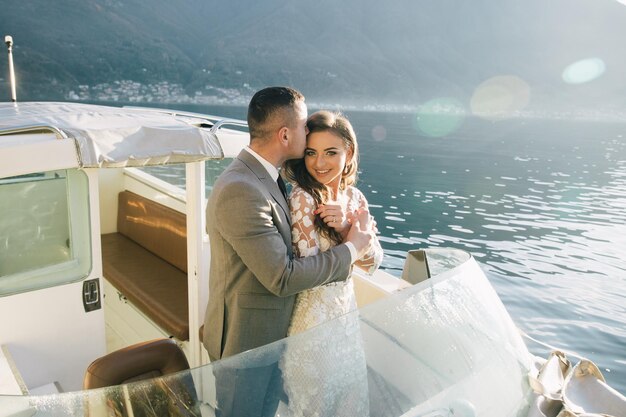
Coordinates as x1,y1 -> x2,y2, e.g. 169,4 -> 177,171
281,111 -> 383,416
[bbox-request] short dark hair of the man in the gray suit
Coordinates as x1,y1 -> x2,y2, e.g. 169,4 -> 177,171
248,87 -> 304,140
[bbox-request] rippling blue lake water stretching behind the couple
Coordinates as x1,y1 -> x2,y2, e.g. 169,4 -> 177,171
141,101 -> 626,393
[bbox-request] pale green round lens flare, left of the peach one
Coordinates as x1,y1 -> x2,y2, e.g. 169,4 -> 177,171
417,97 -> 465,138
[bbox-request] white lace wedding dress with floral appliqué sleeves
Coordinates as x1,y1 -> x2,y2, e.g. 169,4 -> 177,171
281,187 -> 383,417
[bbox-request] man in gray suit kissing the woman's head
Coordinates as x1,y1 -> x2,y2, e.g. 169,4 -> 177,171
203,87 -> 371,416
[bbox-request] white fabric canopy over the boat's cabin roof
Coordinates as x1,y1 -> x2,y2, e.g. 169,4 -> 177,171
0,102 -> 224,168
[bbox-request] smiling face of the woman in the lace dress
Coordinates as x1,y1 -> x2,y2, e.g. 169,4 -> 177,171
304,131 -> 351,188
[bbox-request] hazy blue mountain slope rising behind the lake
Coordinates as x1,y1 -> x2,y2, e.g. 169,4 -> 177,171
0,0 -> 626,112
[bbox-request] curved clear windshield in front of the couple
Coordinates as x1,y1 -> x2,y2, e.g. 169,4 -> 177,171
0,250 -> 531,417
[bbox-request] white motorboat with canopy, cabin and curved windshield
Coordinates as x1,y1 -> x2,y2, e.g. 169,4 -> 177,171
0,102 -> 626,417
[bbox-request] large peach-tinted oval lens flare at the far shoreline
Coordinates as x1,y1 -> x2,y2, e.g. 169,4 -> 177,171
470,75 -> 530,120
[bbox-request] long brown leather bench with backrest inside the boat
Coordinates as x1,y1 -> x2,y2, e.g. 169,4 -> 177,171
102,191 -> 189,341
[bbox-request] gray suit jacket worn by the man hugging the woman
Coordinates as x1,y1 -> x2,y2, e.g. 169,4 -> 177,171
203,150 -> 350,360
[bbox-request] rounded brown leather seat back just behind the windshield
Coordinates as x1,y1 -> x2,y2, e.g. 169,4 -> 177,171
83,339 -> 189,389
